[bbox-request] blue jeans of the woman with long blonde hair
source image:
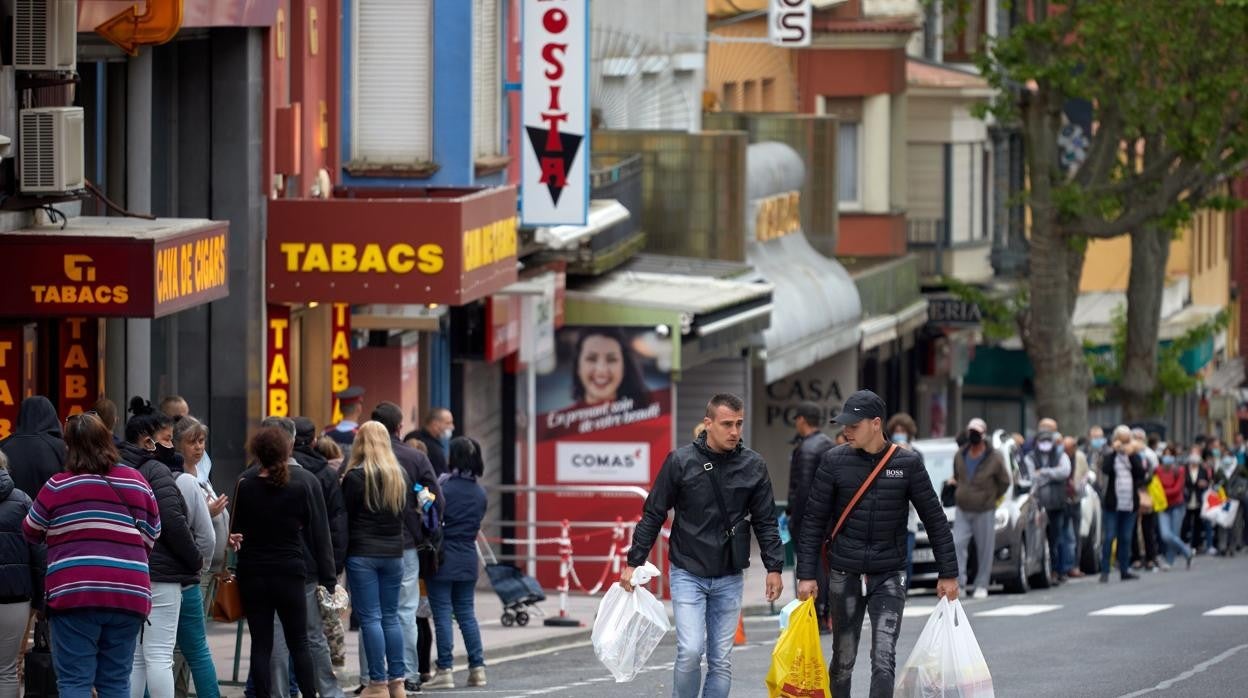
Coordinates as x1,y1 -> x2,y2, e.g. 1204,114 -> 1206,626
347,557 -> 406,683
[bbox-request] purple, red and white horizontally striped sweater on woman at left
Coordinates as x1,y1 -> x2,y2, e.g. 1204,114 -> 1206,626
22,466 -> 160,618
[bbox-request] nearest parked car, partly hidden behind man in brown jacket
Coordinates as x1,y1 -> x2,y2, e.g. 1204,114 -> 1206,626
911,430 -> 1052,593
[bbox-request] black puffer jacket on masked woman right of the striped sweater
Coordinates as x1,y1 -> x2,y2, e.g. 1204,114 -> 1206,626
121,443 -> 203,584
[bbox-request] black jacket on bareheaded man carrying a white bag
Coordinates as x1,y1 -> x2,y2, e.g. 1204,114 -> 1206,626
628,435 -> 784,577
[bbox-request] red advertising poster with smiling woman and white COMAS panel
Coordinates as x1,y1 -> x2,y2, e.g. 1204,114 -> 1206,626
518,326 -> 671,587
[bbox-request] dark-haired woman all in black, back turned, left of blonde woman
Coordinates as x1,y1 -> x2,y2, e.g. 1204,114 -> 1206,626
232,427 -> 341,698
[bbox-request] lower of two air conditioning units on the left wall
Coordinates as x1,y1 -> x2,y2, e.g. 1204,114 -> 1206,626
17,106 -> 86,194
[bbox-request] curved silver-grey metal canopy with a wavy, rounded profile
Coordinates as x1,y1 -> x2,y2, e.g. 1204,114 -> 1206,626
746,230 -> 862,383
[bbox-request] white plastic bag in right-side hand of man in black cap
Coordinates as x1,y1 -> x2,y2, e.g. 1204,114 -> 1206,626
894,598 -> 993,698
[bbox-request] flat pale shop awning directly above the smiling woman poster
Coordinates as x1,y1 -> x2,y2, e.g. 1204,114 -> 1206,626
567,271 -> 774,371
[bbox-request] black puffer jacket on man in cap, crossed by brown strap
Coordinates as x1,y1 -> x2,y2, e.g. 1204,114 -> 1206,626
797,445 -> 957,579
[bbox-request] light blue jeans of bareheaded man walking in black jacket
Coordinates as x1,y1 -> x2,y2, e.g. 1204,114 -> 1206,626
671,564 -> 745,698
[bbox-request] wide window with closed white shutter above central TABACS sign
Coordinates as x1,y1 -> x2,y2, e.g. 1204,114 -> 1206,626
351,0 -> 433,165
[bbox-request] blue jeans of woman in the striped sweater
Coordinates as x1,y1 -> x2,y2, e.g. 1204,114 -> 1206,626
49,611 -> 144,698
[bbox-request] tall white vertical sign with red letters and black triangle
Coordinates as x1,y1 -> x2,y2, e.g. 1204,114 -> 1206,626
520,0 -> 590,226
